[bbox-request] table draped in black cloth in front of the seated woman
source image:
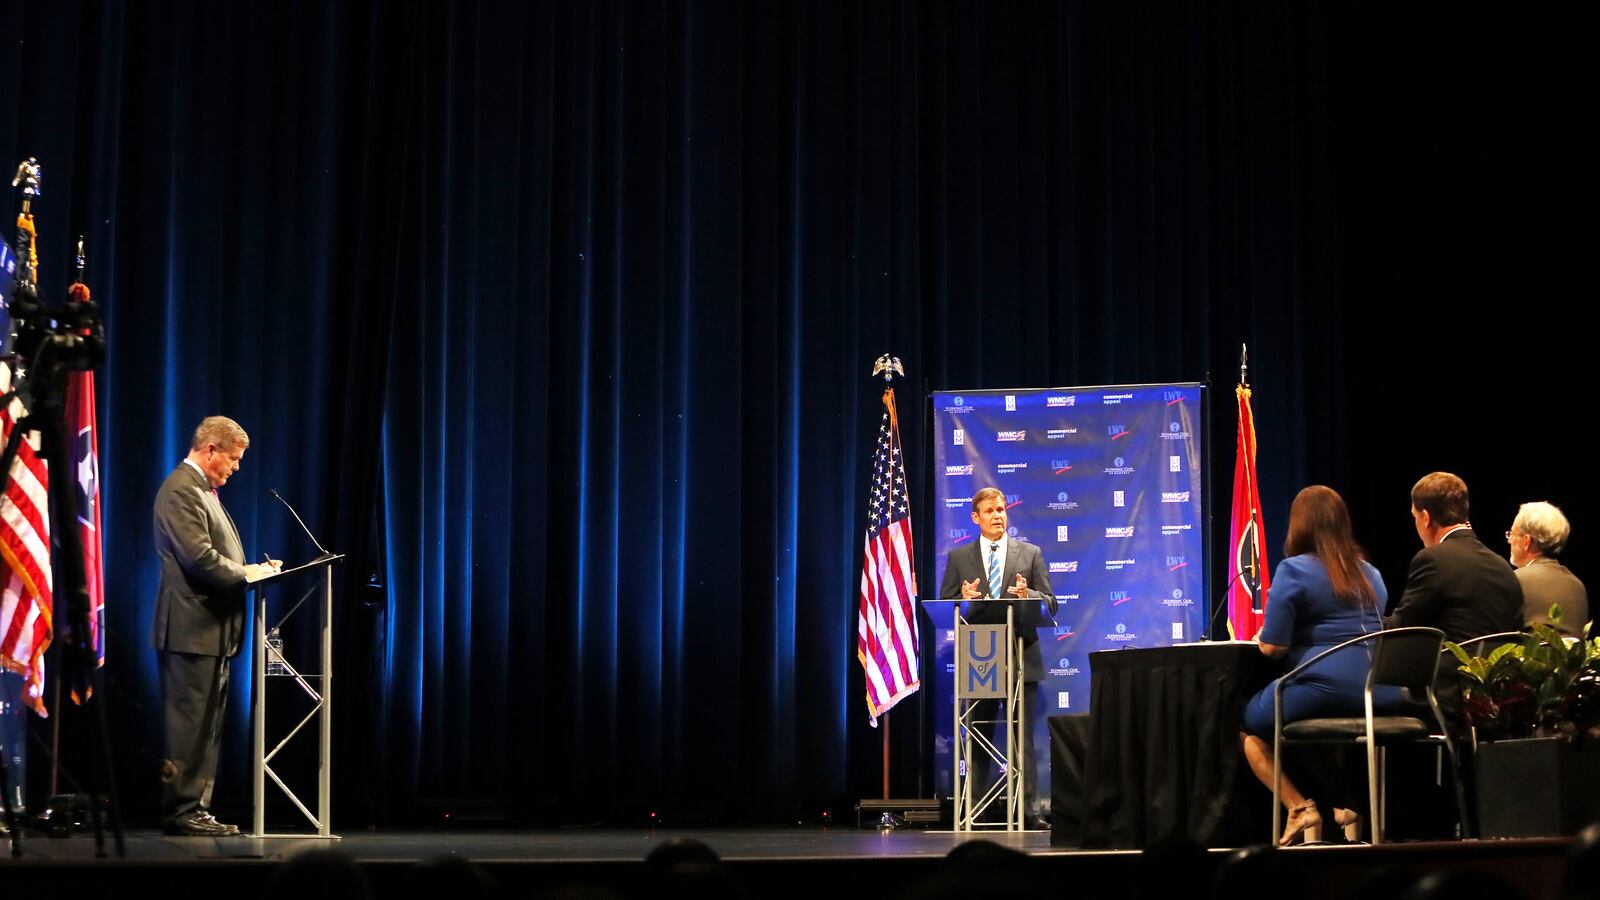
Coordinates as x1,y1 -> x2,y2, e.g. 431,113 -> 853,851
1050,642 -> 1278,849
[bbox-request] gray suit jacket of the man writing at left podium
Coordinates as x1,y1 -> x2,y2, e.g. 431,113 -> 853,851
150,463 -> 246,657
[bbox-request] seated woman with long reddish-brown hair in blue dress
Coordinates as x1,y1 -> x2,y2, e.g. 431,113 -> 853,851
1240,485 -> 1402,844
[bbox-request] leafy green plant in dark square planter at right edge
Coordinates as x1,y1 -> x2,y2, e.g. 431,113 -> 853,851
1446,609 -> 1600,838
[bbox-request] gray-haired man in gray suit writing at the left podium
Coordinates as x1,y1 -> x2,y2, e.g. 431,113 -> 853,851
150,416 -> 278,838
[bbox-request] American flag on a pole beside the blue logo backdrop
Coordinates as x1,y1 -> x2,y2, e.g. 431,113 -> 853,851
856,388 -> 922,727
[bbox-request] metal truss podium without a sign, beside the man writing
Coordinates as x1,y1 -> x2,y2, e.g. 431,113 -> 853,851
248,554 -> 344,839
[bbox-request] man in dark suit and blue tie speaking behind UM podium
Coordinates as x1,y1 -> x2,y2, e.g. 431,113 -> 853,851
939,487 -> 1056,828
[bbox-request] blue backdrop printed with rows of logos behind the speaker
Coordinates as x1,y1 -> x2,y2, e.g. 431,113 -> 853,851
923,384 -> 1210,798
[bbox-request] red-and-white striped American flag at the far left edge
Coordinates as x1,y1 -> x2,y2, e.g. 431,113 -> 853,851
0,362 -> 51,716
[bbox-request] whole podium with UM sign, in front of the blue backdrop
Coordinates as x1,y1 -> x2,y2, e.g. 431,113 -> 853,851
923,599 -> 1038,833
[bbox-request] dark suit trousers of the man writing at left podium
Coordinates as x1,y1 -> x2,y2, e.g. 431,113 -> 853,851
158,650 -> 229,820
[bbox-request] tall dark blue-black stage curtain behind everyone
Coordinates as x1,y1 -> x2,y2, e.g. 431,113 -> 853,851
0,0 -> 1594,828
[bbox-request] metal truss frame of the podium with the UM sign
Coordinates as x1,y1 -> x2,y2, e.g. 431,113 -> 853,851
944,599 -> 1029,833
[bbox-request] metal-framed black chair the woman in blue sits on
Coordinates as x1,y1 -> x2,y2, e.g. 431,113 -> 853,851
1272,628 -> 1469,844
